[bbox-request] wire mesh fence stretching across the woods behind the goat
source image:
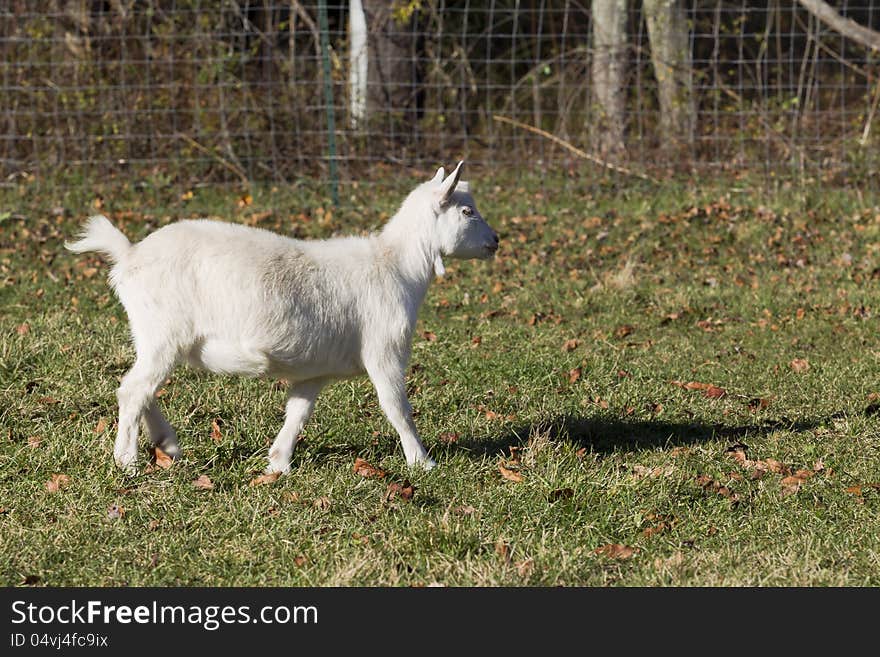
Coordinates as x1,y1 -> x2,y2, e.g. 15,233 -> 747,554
0,0 -> 880,197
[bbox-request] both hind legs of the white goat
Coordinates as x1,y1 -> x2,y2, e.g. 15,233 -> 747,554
113,351 -> 177,472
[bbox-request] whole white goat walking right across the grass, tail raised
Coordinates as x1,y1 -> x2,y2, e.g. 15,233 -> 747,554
66,162 -> 498,473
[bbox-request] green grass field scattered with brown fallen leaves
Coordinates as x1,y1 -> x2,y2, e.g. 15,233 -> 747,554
0,172 -> 880,586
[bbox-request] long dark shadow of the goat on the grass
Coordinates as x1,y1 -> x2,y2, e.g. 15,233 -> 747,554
449,415 -> 836,458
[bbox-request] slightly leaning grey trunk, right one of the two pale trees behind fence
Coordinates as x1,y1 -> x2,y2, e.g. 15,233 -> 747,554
644,0 -> 696,145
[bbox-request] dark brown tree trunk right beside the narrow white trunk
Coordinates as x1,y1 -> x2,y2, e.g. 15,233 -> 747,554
362,0 -> 420,125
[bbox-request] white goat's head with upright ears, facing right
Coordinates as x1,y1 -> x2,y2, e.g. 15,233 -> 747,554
428,162 -> 498,274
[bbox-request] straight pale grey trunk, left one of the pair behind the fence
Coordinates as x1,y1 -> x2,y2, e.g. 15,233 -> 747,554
592,0 -> 627,160
